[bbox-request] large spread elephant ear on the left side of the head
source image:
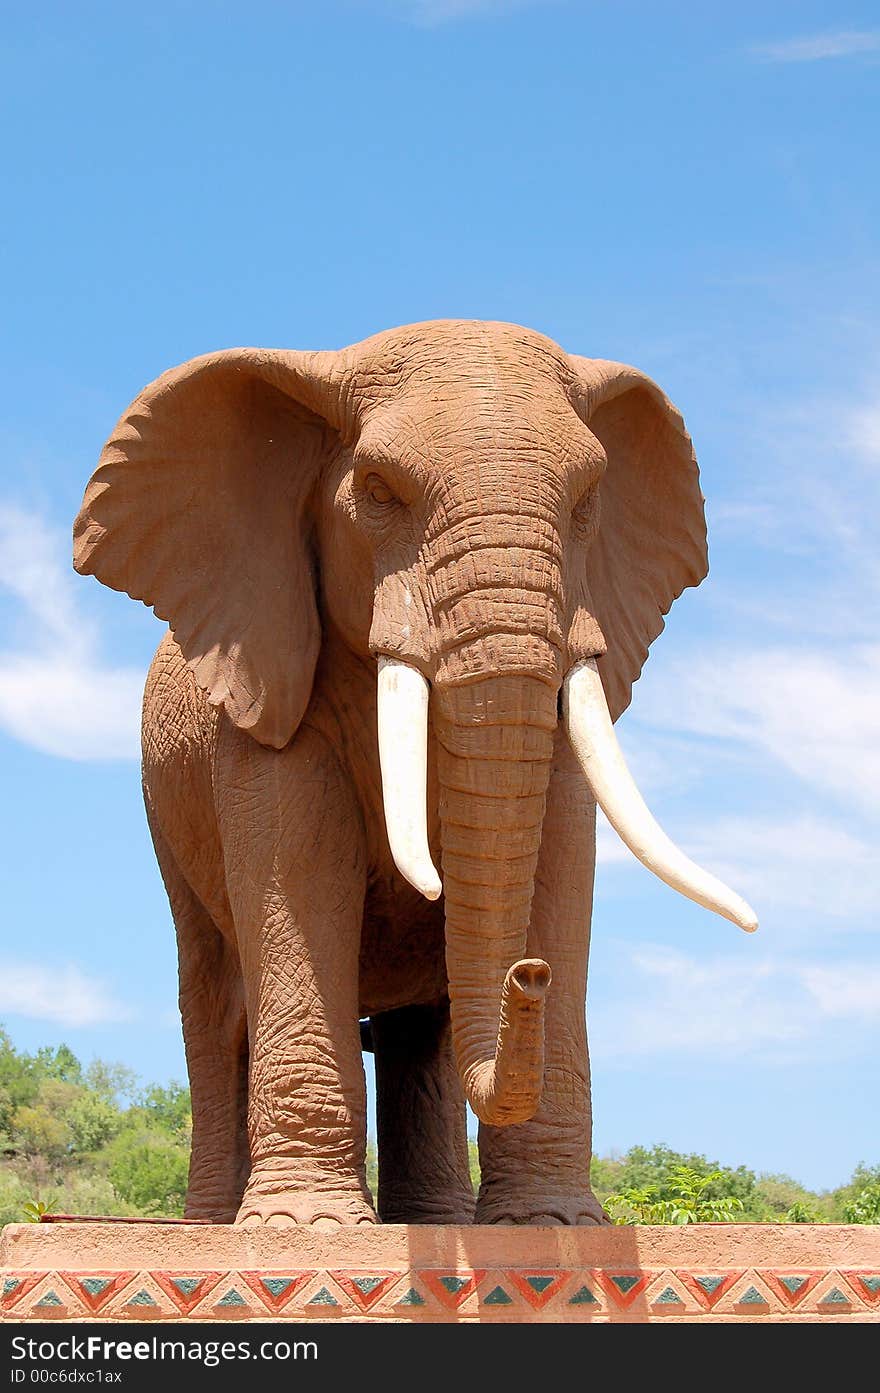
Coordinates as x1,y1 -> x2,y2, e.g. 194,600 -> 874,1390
74,348 -> 341,749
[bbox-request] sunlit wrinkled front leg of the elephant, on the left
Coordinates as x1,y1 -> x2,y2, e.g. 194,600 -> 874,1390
221,729 -> 377,1227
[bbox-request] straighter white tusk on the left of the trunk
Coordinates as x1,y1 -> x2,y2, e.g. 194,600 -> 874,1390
379,657 -> 443,900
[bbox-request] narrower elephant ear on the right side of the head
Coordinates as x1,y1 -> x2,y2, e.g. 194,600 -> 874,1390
571,355 -> 709,720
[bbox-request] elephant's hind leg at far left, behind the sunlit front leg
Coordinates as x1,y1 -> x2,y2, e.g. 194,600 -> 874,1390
153,829 -> 251,1223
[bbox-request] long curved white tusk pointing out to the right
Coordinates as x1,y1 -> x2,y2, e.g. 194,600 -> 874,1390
563,657 -> 757,933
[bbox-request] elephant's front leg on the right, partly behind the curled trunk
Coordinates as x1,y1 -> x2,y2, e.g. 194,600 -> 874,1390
475,731 -> 608,1224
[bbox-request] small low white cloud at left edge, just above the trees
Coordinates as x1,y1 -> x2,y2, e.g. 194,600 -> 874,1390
0,961 -> 131,1027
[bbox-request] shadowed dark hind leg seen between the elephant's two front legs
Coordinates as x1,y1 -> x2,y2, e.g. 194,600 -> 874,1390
370,1002 -> 473,1224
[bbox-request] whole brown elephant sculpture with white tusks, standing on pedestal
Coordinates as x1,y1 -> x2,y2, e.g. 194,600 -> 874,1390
74,320 -> 756,1227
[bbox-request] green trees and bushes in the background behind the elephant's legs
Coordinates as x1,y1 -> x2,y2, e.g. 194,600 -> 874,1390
0,1027 -> 880,1224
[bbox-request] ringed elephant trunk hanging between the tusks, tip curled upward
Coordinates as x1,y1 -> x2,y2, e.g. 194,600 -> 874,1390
433,673 -> 557,1127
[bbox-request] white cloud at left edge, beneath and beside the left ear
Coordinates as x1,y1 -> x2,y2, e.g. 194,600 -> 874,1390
0,506 -> 143,759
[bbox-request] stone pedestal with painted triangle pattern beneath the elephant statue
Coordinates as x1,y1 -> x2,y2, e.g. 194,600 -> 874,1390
0,1222 -> 880,1323
